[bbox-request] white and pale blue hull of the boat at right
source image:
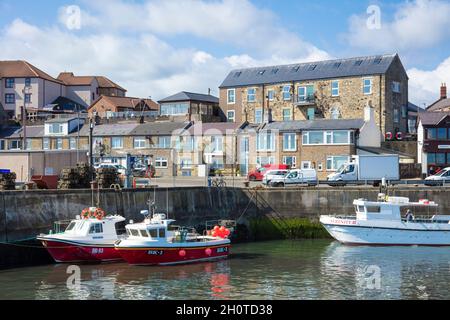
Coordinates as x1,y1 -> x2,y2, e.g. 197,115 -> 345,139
321,218 -> 450,246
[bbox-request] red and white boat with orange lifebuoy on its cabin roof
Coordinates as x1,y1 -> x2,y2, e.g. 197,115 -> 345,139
36,207 -> 125,263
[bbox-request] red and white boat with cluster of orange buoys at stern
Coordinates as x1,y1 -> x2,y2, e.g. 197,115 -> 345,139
115,210 -> 230,265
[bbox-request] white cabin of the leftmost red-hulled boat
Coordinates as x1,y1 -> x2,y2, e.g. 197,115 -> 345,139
60,215 -> 125,238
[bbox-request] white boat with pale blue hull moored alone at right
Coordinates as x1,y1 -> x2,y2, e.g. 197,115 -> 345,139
320,194 -> 450,246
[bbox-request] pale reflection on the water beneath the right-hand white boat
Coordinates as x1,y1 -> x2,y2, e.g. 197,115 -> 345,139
321,243 -> 450,299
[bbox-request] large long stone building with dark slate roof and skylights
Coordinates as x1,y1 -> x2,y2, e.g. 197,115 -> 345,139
220,54 -> 408,134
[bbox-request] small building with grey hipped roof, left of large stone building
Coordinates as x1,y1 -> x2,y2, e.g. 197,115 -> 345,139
158,91 -> 220,122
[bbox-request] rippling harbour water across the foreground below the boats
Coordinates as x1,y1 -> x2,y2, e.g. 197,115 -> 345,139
0,240 -> 450,300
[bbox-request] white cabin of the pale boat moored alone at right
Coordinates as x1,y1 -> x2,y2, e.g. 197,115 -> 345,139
353,197 -> 440,223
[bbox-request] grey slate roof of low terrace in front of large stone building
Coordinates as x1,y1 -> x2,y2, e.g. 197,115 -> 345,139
262,119 -> 364,131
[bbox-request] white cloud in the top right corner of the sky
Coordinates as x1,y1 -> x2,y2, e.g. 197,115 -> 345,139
344,0 -> 450,52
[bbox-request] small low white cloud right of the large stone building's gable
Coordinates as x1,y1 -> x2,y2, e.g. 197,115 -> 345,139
407,57 -> 450,106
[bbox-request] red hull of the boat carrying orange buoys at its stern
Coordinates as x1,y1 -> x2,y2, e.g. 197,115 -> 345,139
116,244 -> 230,265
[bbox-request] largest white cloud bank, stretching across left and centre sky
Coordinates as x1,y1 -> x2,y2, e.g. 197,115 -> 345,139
0,0 -> 329,99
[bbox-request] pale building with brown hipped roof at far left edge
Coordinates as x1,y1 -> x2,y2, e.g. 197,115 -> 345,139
0,61 -> 65,117
